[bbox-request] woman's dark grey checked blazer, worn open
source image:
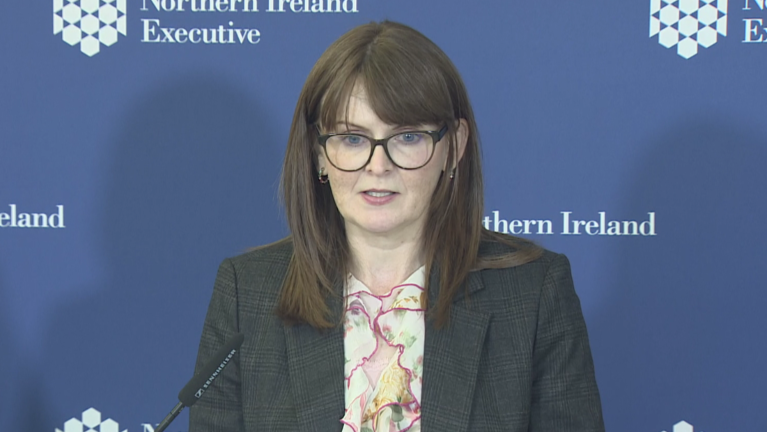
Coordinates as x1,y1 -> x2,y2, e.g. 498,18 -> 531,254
189,242 -> 604,432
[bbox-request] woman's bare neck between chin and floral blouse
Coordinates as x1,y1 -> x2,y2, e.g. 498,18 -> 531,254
347,228 -> 424,295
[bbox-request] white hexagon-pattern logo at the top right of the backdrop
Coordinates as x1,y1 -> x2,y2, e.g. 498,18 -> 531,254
650,0 -> 727,59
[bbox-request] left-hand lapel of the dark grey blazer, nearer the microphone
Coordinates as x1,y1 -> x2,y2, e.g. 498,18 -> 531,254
285,287 -> 345,432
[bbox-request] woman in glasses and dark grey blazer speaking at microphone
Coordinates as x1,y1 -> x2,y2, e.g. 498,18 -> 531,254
190,22 -> 604,432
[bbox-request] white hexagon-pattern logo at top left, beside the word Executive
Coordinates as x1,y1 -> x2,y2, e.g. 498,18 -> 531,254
53,0 -> 127,57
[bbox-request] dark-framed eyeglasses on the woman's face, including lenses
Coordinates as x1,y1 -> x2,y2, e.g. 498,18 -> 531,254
318,125 -> 447,172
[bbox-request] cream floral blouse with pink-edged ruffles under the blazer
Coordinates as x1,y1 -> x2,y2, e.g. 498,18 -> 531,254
341,267 -> 426,432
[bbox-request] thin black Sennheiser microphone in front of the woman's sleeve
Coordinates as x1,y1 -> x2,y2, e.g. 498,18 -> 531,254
154,333 -> 245,432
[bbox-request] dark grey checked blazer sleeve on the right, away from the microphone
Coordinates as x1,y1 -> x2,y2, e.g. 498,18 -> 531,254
529,255 -> 605,432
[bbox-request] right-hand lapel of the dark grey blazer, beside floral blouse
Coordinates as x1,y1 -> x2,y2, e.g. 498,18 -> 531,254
421,270 -> 490,432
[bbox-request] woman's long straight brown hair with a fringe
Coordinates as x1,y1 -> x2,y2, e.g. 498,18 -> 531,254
277,21 -> 541,329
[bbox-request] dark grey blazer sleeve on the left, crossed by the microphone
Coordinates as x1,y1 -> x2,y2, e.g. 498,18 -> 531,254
189,259 -> 245,432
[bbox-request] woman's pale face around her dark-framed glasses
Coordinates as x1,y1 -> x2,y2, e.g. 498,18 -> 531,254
318,86 -> 467,242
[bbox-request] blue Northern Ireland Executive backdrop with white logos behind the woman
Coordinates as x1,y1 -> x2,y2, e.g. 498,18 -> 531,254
0,0 -> 767,432
